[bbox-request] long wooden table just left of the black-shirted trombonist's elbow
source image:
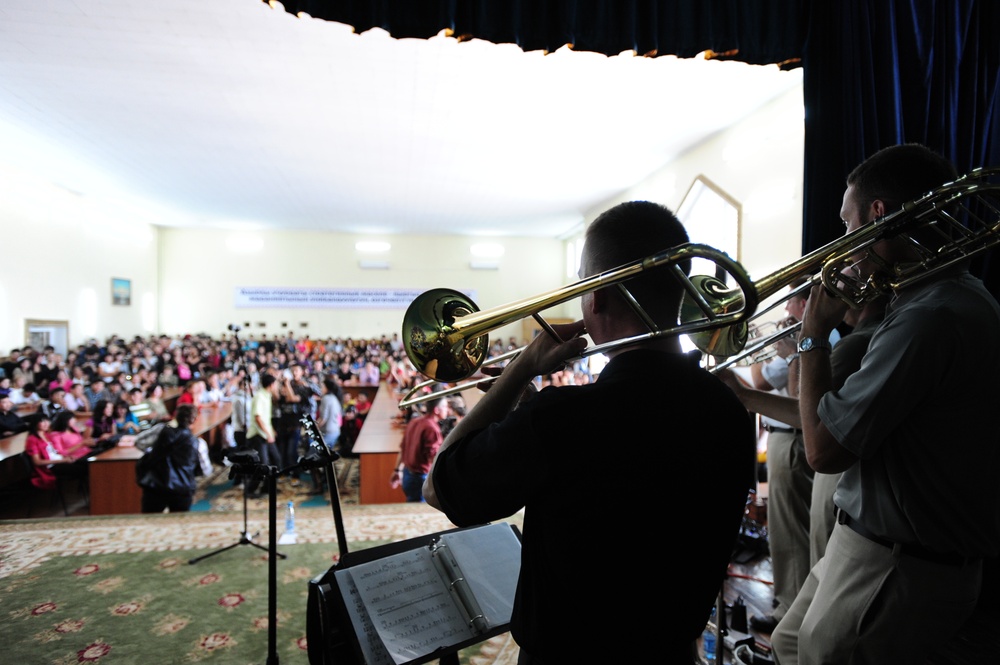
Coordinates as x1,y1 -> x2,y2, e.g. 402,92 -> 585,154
354,381 -> 482,503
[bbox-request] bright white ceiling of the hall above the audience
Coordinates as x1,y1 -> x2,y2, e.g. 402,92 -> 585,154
0,0 -> 801,237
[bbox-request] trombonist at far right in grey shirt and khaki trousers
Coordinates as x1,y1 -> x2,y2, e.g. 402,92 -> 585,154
772,144 -> 1000,665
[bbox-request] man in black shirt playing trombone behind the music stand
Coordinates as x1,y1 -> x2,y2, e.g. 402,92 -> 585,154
424,202 -> 755,665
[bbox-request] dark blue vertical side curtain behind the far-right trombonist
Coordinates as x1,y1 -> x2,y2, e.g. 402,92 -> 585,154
802,0 -> 1000,252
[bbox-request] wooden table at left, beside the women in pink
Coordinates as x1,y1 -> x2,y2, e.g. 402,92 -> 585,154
87,402 -> 233,515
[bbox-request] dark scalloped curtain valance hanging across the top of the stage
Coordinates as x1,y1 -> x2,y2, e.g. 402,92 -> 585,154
274,0 -> 806,65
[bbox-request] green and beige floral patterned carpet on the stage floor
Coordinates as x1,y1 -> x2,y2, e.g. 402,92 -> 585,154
0,477 -> 519,665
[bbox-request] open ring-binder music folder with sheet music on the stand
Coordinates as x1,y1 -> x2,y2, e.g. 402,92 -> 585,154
308,522 -> 521,665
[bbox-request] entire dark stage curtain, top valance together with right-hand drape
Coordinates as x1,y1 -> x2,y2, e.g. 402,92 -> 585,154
270,0 -> 1000,286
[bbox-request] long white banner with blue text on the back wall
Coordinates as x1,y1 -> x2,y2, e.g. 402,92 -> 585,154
235,286 -> 423,309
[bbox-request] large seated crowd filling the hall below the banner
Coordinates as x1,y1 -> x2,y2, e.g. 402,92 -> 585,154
0,334 -> 590,506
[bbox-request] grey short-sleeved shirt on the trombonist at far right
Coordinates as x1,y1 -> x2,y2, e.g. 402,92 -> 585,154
819,273 -> 1000,557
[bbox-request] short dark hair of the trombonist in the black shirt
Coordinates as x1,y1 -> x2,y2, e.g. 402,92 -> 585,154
584,201 -> 691,325
